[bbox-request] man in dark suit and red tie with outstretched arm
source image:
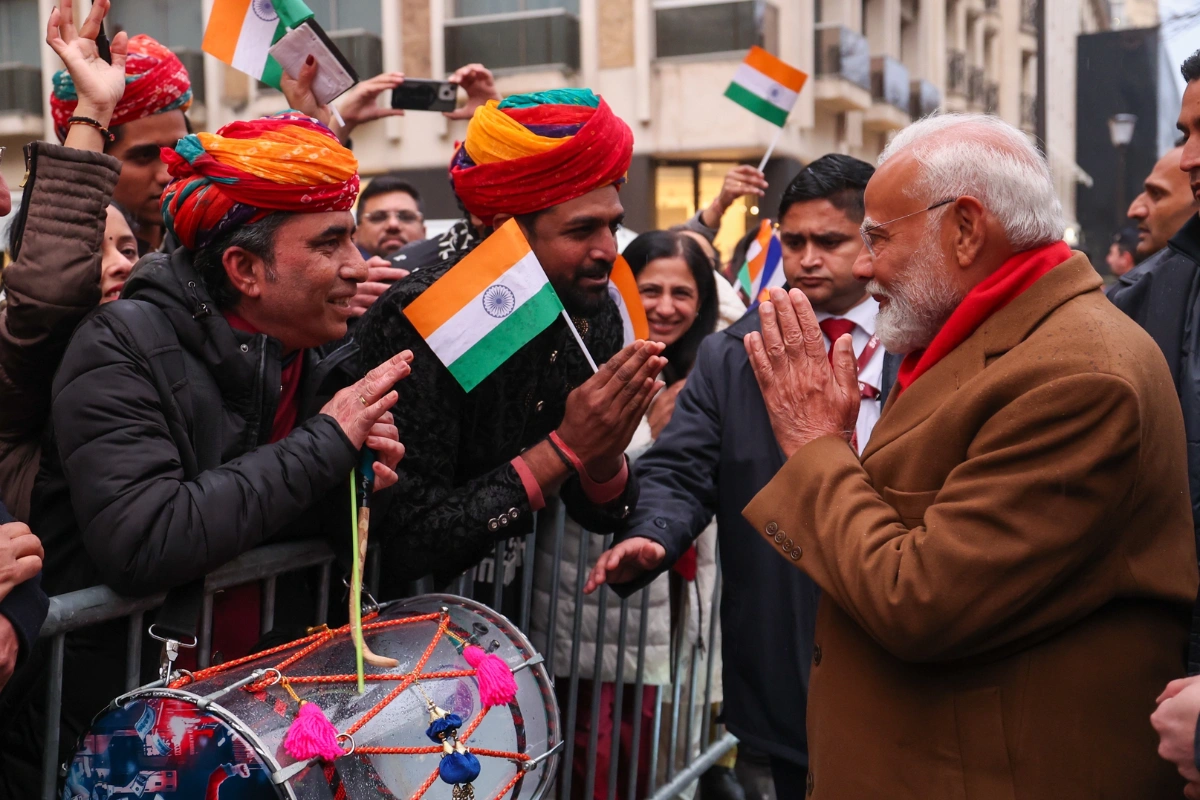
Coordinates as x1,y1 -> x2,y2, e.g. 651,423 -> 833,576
587,155 -> 899,798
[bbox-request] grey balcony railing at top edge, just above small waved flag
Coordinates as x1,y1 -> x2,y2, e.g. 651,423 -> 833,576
654,0 -> 779,59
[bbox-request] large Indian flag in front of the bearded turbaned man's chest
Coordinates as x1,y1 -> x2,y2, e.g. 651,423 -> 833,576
404,219 -> 563,392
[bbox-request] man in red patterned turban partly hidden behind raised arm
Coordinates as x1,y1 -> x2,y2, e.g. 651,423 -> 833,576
50,34 -> 192,253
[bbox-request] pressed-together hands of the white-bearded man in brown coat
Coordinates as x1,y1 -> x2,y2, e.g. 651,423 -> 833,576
743,289 -> 860,458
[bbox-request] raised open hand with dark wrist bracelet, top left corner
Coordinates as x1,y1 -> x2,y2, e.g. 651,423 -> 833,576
46,0 -> 130,127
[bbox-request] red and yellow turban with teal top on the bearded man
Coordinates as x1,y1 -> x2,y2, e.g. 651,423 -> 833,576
450,89 -> 634,225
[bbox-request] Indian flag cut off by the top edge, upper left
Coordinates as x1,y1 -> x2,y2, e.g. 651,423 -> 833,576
202,0 -> 313,89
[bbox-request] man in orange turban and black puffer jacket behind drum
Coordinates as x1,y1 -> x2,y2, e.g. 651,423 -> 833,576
31,114 -> 410,772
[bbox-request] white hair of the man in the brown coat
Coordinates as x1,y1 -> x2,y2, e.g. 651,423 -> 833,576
880,114 -> 1067,252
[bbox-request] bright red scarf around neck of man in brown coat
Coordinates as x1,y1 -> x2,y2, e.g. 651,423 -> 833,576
896,241 -> 1070,391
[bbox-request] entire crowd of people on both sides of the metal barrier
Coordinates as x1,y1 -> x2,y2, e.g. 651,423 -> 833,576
0,0 -> 1200,800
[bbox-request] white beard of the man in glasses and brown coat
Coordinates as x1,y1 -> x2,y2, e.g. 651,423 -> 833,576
866,249 -> 964,355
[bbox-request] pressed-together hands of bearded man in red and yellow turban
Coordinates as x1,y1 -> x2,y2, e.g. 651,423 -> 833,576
558,342 -> 667,482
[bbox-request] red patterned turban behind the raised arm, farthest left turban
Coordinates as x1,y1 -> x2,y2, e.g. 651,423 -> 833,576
50,34 -> 192,142
